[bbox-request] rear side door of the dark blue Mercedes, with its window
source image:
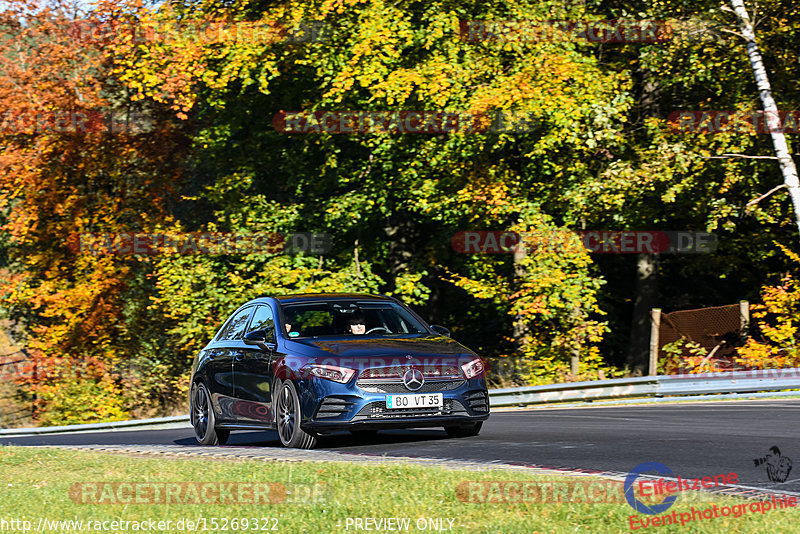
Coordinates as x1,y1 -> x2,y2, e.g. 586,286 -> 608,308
208,306 -> 253,422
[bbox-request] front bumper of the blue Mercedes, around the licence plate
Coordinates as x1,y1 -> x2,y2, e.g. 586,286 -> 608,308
298,377 -> 489,432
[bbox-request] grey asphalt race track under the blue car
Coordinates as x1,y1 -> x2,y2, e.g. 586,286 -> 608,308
0,400 -> 800,492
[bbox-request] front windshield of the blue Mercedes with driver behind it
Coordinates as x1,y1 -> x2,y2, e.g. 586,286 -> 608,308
282,301 -> 427,339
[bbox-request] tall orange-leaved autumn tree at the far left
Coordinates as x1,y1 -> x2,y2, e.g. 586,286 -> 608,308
0,1 -> 189,423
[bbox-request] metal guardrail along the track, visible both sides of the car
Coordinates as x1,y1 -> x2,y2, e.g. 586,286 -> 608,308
0,368 -> 800,437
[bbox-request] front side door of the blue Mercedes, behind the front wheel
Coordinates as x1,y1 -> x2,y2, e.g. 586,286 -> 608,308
233,304 -> 275,423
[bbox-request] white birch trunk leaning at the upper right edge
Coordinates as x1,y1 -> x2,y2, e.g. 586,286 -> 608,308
731,0 -> 800,231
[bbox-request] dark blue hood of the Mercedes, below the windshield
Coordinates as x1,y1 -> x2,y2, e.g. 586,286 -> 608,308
286,335 -> 475,358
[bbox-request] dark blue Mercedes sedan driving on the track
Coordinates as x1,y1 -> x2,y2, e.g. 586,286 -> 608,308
190,294 -> 489,449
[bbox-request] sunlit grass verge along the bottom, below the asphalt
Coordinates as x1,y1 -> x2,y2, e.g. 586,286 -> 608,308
0,447 -> 800,534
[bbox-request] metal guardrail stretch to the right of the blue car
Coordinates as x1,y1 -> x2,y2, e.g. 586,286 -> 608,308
489,368 -> 800,408
